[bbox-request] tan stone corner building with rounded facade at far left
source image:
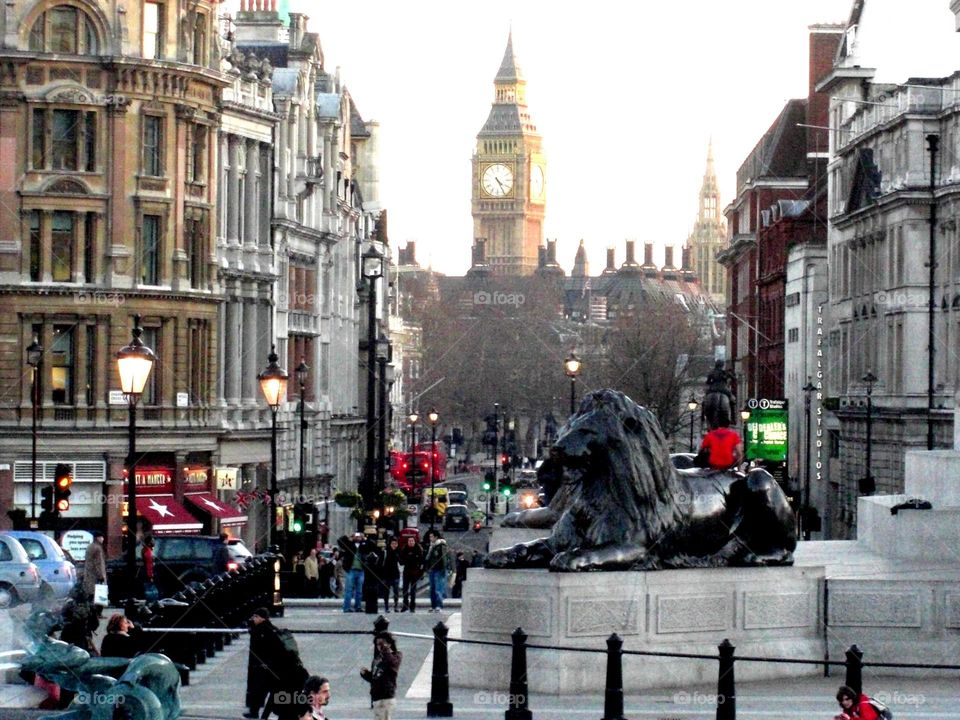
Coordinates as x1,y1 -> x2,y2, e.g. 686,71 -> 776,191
0,0 -> 228,553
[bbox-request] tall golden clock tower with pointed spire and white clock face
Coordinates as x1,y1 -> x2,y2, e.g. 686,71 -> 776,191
471,33 -> 547,275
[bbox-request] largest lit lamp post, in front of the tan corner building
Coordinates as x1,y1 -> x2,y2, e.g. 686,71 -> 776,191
117,315 -> 157,579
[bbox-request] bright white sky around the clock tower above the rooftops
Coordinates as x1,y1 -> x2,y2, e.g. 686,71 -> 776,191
228,0 -> 960,274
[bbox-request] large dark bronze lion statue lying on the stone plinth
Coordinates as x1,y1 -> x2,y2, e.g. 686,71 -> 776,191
485,390 -> 797,572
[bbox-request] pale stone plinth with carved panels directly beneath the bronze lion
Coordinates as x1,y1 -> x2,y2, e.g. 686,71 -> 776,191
450,567 -> 824,694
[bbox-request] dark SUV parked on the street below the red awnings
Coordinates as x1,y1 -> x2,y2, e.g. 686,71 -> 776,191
107,535 -> 253,602
